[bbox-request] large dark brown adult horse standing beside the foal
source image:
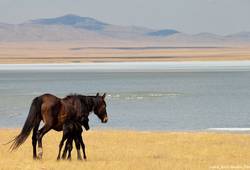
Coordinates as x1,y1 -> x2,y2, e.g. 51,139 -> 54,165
11,93 -> 108,159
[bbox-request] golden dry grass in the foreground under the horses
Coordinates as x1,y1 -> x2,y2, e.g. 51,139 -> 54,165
0,129 -> 250,170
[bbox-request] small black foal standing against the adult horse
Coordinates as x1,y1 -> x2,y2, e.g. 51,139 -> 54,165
57,117 -> 89,160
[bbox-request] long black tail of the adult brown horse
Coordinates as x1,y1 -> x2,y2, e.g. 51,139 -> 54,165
10,97 -> 41,151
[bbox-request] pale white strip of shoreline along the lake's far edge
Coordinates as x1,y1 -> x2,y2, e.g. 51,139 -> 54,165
0,60 -> 250,72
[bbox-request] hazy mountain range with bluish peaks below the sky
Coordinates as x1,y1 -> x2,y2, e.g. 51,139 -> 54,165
0,14 -> 250,44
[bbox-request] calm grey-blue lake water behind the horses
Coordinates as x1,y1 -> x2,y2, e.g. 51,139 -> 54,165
0,67 -> 250,131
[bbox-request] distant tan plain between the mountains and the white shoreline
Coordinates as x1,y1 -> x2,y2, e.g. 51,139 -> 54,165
0,42 -> 250,64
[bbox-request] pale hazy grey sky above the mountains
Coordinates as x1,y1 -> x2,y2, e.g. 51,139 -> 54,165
0,0 -> 250,34
